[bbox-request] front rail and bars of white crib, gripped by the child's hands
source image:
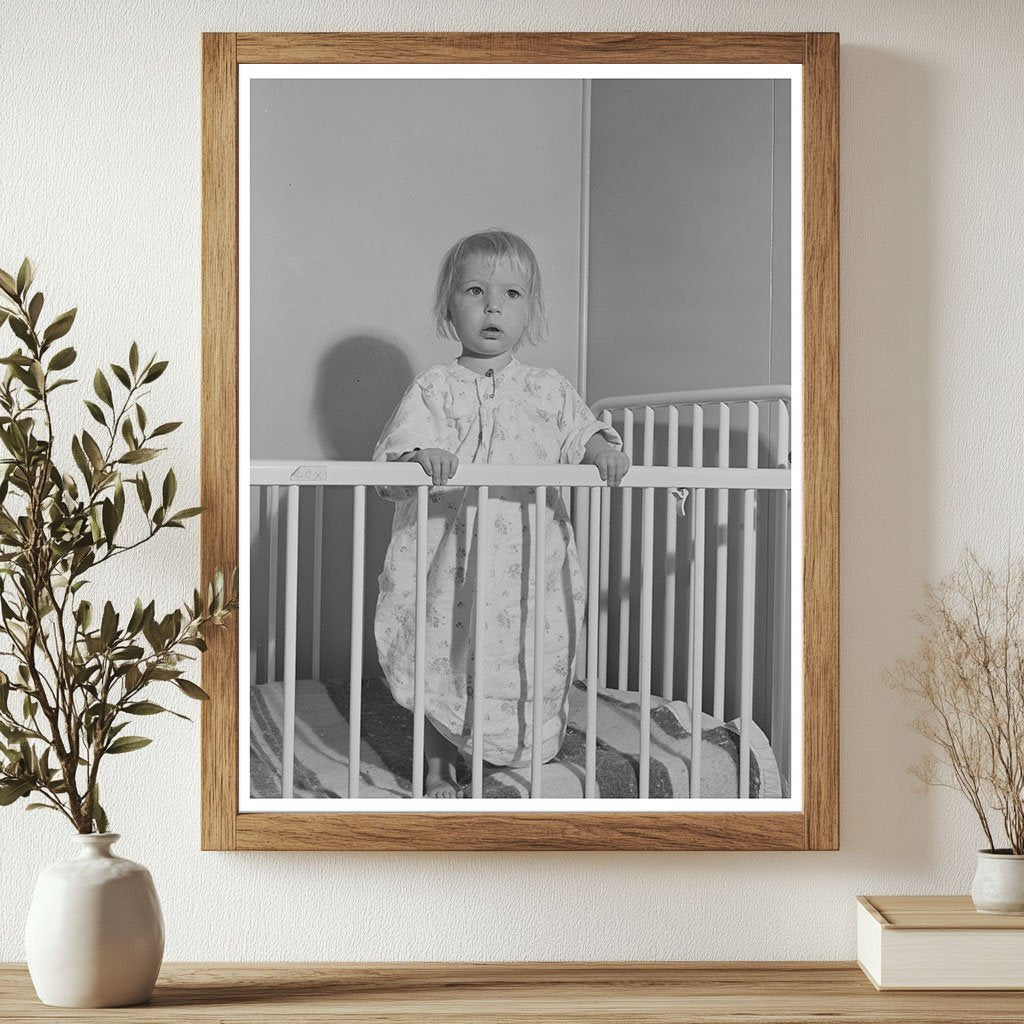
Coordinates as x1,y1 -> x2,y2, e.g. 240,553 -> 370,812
250,461 -> 790,800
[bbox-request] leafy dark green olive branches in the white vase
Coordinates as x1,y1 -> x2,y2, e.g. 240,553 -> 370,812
0,259 -> 238,834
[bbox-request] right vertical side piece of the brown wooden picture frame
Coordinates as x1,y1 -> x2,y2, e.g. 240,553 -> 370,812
804,33 -> 840,850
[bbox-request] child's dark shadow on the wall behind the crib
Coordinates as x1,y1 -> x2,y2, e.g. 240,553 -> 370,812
251,334 -> 415,680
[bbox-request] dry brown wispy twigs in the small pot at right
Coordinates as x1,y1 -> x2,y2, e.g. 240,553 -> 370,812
893,552 -> 1024,854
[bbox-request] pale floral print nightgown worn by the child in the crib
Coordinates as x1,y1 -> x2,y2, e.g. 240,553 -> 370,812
374,358 -> 622,765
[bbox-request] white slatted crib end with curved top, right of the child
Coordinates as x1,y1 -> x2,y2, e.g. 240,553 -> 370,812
573,384 -> 792,797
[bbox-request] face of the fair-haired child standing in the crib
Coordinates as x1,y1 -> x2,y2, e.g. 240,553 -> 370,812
449,256 -> 529,355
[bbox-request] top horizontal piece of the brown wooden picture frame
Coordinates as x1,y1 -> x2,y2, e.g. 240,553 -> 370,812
238,32 -> 804,63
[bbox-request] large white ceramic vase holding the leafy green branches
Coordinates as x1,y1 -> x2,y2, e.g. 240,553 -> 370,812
25,833 -> 164,1007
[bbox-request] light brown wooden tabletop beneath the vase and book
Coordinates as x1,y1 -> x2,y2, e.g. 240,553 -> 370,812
0,963 -> 1024,1024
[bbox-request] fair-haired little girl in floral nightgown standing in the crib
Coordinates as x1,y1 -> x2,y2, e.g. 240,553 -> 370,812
374,230 -> 630,798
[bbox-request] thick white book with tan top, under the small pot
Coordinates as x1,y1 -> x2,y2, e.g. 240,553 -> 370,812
857,896 -> 1024,987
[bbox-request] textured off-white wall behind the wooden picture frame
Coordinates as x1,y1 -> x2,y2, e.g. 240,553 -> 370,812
0,0 -> 1024,961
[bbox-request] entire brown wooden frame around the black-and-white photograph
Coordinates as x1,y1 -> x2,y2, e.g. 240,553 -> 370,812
202,33 -> 839,850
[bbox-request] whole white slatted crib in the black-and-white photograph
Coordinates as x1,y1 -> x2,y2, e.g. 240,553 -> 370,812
250,386 -> 792,799
